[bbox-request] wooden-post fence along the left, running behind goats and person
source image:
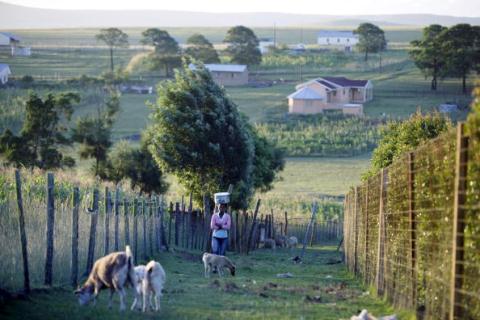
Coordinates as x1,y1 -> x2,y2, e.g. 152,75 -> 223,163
0,168 -> 341,294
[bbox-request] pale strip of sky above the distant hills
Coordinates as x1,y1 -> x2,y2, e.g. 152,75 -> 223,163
0,0 -> 480,17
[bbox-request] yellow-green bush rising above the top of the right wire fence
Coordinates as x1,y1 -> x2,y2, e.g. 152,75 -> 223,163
364,111 -> 452,178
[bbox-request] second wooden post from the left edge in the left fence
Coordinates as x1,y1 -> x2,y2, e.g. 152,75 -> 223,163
44,172 -> 55,286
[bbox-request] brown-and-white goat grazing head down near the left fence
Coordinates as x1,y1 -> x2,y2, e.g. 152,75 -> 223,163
75,246 -> 137,311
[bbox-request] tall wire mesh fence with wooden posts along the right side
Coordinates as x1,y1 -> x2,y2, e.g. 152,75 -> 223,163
344,123 -> 480,319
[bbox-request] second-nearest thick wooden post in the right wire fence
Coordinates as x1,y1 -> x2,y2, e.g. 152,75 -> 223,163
408,152 -> 417,307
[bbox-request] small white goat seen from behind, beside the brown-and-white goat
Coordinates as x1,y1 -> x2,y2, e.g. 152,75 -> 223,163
130,260 -> 167,312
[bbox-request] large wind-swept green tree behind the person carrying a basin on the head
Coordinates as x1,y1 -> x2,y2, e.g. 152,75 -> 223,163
148,67 -> 283,208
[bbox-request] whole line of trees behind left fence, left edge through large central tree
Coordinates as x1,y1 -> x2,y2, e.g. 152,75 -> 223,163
0,66 -> 284,208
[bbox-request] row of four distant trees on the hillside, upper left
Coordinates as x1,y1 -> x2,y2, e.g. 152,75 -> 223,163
96,26 -> 262,76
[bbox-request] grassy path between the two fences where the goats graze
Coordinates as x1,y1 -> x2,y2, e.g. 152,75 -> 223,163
0,246 -> 413,320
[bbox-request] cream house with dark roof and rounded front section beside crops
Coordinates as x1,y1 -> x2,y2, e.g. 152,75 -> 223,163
287,77 -> 373,115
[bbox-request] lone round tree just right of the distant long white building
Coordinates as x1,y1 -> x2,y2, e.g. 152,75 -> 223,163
354,23 -> 387,61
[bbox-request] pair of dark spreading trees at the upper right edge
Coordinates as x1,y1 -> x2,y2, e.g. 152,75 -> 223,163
410,24 -> 480,93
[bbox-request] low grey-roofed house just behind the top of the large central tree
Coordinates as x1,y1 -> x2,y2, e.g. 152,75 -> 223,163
189,64 -> 248,86
